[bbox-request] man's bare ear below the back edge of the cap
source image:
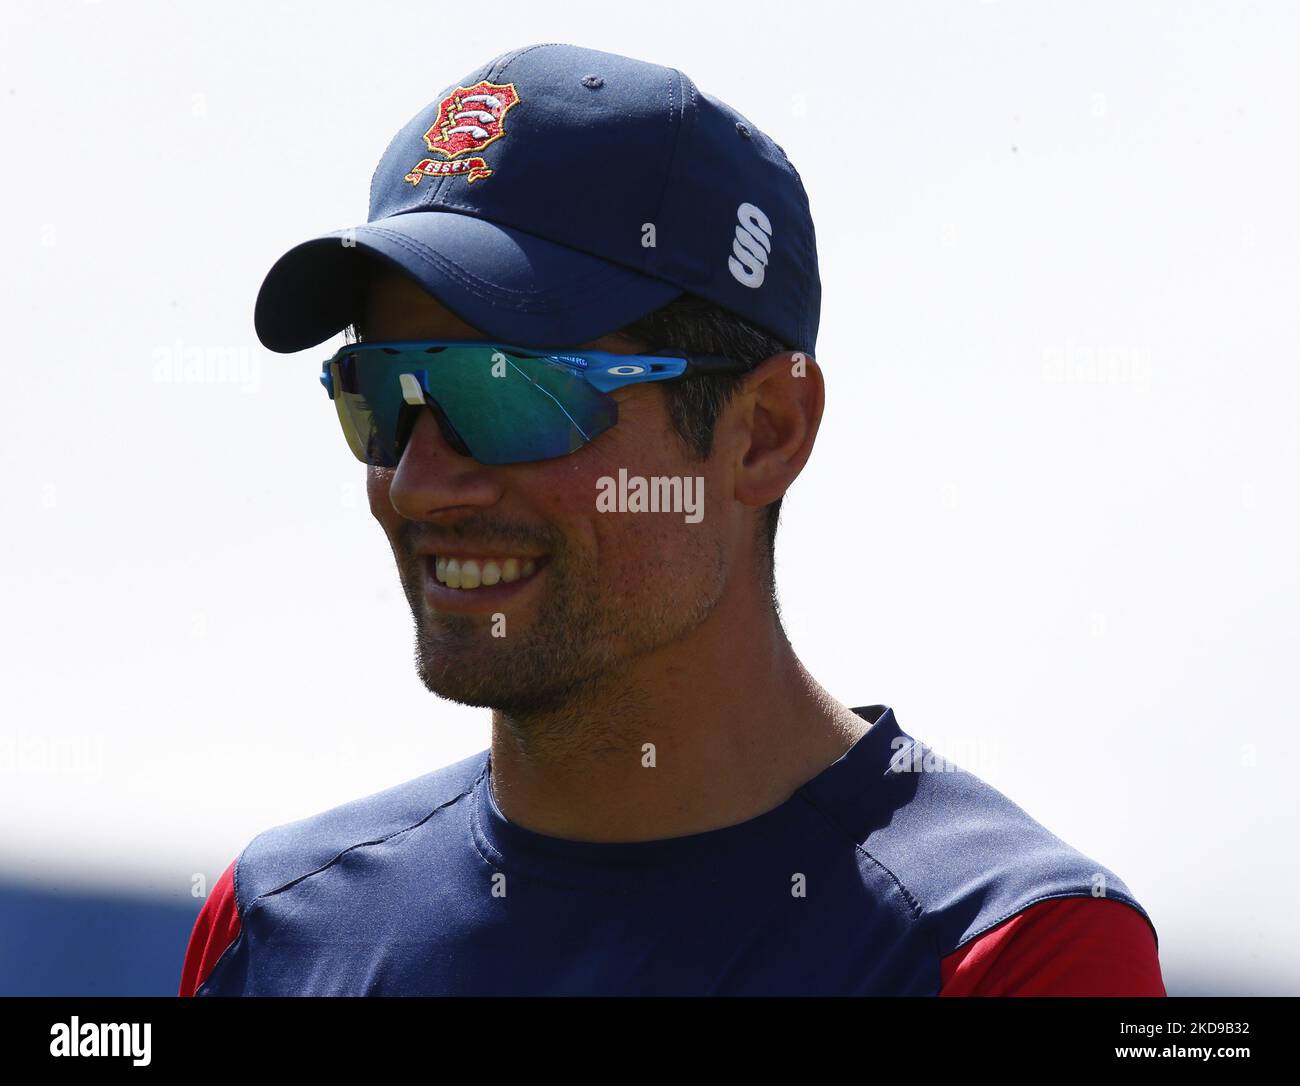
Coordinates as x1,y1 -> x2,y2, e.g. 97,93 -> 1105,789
731,351 -> 826,515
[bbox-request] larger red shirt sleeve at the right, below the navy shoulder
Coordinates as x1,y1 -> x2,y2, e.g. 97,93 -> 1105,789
939,897 -> 1166,996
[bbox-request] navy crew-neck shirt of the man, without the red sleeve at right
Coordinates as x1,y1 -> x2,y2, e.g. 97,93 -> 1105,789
182,705 -> 1162,995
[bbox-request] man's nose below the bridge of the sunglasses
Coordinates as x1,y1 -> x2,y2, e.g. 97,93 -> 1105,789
389,407 -> 501,520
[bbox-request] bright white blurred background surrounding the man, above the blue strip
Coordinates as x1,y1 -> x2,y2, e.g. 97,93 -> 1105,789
0,0 -> 1300,992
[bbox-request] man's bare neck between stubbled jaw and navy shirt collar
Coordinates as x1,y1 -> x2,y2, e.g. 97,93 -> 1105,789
491,611 -> 868,841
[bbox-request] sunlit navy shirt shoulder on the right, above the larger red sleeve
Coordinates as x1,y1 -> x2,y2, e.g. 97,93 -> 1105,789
811,713 -> 1154,955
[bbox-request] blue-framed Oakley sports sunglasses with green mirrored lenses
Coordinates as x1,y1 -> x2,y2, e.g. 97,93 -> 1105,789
321,339 -> 750,467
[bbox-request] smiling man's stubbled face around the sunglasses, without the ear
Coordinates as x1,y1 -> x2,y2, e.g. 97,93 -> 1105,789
360,273 -> 742,717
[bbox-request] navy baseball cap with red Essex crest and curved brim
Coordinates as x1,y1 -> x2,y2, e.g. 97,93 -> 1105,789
254,43 -> 822,354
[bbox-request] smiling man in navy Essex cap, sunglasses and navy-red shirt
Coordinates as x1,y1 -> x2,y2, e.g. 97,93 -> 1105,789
181,44 -> 1164,995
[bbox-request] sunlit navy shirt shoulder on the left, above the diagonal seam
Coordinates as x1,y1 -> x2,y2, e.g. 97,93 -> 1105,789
234,750 -> 488,913
